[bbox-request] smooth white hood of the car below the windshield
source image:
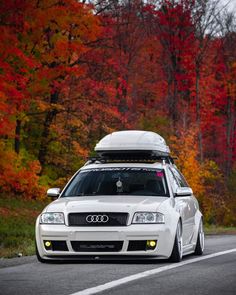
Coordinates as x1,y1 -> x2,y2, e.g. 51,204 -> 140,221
45,195 -> 170,214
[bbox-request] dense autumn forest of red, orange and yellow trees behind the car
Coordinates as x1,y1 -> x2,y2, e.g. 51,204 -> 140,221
0,0 -> 236,226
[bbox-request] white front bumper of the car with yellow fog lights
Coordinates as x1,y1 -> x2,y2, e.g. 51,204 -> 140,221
36,220 -> 174,259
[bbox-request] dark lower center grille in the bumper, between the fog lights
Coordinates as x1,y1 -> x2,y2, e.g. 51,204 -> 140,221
71,241 -> 123,252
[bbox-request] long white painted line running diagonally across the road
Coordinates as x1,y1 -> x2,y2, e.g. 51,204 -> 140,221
71,248 -> 236,295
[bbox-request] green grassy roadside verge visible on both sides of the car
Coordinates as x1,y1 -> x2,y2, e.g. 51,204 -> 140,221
0,195 -> 236,258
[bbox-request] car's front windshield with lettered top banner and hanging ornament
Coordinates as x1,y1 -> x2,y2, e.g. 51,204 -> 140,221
62,168 -> 168,197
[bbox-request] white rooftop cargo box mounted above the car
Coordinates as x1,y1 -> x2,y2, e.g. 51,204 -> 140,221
95,130 -> 170,156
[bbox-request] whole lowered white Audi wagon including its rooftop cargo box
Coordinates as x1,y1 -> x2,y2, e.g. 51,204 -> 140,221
36,130 -> 204,262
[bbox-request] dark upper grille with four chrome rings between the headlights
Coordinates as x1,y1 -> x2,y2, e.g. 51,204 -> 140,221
68,212 -> 128,226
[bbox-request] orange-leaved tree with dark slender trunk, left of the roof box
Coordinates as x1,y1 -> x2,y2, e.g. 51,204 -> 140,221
21,0 -> 98,170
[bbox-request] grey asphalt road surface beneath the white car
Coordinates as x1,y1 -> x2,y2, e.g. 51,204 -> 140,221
0,235 -> 236,295
